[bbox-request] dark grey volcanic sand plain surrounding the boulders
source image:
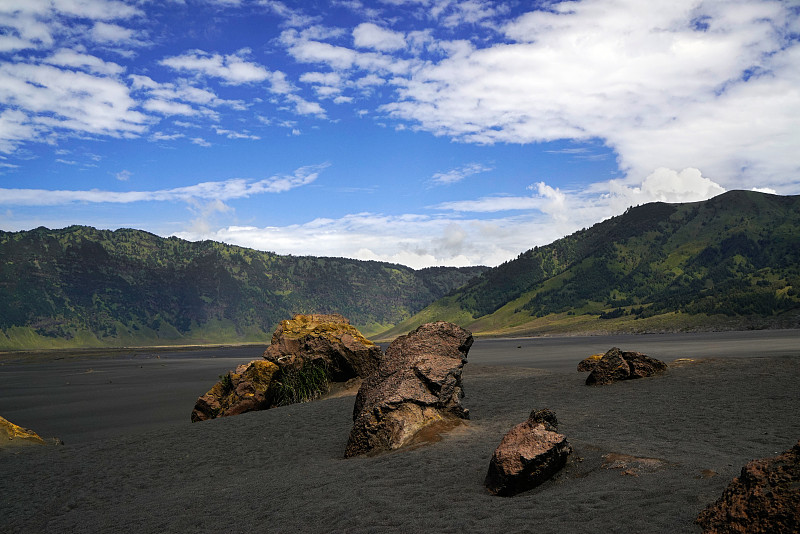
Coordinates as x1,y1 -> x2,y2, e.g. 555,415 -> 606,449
0,331 -> 800,533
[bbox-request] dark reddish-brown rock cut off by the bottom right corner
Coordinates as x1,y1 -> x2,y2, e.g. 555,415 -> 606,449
696,441 -> 800,534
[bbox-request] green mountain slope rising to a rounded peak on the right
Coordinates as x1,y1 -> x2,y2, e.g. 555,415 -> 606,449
380,191 -> 800,338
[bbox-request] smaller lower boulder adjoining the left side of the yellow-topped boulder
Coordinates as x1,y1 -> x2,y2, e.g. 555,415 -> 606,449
192,360 -> 278,422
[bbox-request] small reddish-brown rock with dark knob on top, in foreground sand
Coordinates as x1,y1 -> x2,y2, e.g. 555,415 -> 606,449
484,409 -> 572,497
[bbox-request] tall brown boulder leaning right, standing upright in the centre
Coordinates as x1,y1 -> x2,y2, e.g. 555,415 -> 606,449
345,321 -> 472,458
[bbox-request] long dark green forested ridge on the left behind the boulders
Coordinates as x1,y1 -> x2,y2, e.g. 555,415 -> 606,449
0,226 -> 486,349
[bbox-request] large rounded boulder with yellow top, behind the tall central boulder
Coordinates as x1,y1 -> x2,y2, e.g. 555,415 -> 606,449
264,314 -> 383,382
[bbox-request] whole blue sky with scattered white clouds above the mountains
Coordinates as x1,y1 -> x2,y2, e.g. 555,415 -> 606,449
0,0 -> 800,267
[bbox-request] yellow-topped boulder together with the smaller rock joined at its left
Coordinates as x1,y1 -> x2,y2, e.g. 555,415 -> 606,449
192,314 -> 383,422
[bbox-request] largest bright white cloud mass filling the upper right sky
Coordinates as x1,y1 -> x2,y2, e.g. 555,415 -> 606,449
380,0 -> 800,192
